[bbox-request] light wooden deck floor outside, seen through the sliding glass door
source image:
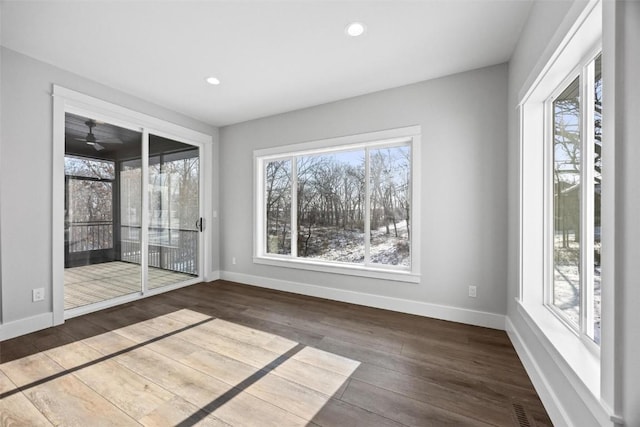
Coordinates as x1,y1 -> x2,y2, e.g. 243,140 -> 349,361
64,261 -> 193,310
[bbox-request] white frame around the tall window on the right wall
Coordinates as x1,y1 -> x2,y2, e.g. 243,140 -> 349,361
516,0 -> 614,410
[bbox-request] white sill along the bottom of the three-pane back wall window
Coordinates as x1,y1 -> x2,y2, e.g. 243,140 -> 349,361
253,256 -> 420,283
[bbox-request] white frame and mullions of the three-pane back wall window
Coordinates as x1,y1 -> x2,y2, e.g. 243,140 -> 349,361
253,126 -> 421,283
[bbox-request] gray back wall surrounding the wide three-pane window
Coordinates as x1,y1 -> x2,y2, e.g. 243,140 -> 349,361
220,64 -> 507,314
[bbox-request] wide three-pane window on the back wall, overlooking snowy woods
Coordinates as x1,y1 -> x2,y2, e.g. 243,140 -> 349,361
255,127 -> 419,281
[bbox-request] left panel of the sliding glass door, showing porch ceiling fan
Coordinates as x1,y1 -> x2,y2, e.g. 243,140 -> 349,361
64,113 -> 143,310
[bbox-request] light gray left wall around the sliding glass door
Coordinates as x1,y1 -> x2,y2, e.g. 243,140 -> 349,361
0,48 -> 219,334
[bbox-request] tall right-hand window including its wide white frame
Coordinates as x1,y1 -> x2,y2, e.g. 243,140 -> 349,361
517,0 -> 604,407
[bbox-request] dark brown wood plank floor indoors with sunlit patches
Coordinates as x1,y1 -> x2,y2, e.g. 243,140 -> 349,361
0,281 -> 551,427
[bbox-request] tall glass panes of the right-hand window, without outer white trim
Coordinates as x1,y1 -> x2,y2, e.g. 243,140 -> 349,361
548,55 -> 602,344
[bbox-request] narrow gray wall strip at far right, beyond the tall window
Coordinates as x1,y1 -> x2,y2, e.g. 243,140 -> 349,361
602,1 -> 640,426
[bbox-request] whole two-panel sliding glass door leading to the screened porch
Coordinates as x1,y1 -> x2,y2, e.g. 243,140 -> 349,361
64,113 -> 203,314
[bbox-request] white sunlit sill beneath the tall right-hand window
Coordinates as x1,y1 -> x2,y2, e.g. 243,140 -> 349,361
516,299 -> 600,402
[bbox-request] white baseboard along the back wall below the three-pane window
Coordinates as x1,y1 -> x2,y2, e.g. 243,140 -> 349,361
221,271 -> 506,330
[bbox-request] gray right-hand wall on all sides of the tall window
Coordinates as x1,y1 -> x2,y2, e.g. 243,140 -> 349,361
508,0 -> 640,426
